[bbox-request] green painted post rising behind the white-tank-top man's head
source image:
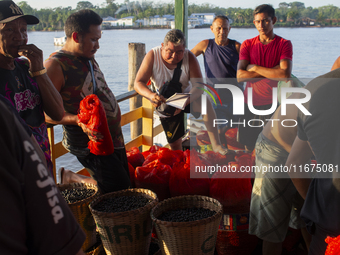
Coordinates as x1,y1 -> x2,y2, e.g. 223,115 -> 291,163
175,0 -> 188,46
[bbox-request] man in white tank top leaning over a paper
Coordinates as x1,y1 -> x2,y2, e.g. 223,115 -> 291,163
134,29 -> 227,154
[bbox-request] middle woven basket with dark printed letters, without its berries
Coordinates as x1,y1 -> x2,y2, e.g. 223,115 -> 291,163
90,189 -> 158,255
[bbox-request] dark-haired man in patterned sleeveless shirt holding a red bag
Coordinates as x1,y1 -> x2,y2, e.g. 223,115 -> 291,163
45,10 -> 131,193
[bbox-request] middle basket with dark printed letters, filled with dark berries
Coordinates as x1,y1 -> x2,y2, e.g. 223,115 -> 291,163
89,189 -> 158,255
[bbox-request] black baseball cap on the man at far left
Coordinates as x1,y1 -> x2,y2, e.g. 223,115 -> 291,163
0,1 -> 39,25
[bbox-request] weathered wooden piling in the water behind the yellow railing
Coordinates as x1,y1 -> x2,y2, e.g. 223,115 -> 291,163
128,43 -> 145,139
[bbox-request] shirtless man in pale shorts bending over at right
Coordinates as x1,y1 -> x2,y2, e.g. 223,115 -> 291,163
249,93 -> 310,255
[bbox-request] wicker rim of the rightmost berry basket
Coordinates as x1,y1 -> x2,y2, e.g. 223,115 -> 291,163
150,195 -> 223,227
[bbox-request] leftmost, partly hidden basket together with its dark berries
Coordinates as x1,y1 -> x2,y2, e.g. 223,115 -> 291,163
58,183 -> 98,251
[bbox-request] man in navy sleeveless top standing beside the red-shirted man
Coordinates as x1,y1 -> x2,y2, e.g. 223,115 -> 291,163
191,15 -> 243,143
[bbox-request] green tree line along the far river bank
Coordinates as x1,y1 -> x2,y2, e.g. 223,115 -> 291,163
18,0 -> 340,31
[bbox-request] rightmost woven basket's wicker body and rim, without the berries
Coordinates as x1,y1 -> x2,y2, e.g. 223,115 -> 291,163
151,195 -> 223,255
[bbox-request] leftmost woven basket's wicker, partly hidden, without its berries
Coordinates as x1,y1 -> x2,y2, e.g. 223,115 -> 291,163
58,183 -> 99,251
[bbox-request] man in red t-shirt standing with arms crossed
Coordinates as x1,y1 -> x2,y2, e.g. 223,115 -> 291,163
237,4 -> 293,150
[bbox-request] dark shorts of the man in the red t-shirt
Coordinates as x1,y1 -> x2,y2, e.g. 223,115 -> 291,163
238,104 -> 273,149
